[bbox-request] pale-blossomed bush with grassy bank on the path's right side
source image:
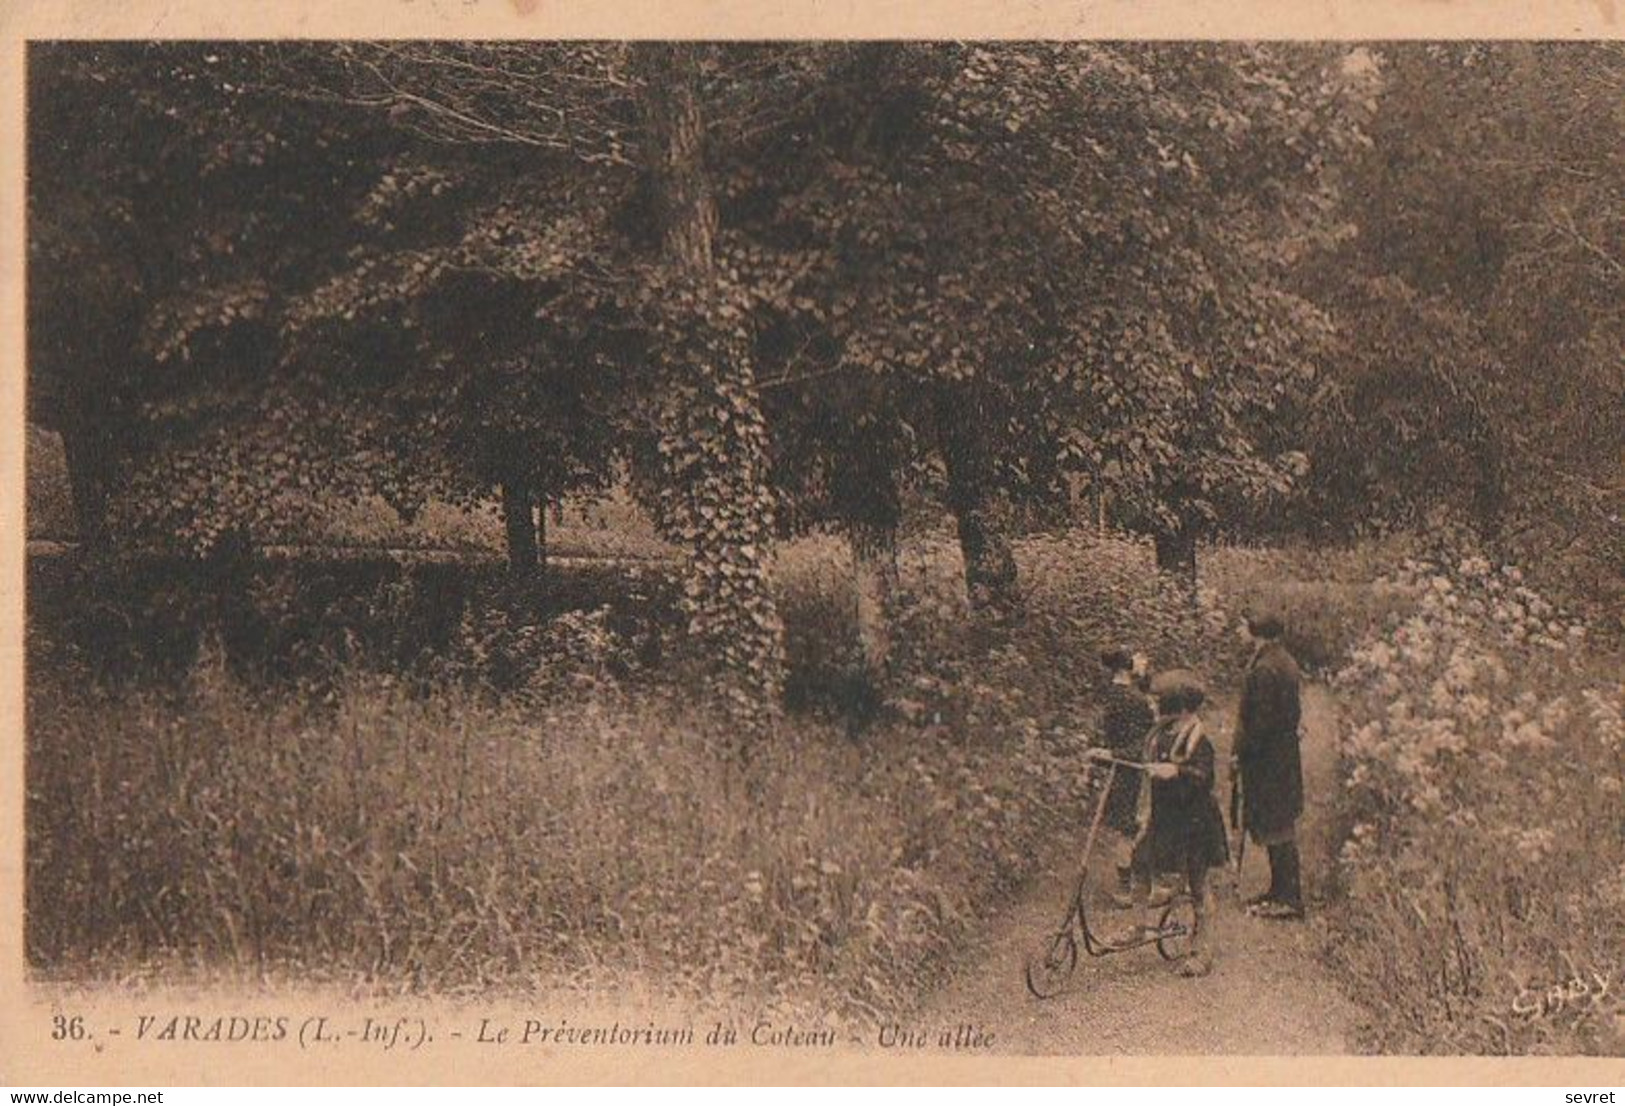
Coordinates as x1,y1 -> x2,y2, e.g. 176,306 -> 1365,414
1333,555 -> 1625,1054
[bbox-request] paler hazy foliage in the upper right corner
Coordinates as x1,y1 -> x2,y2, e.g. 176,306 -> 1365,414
1305,42 -> 1625,630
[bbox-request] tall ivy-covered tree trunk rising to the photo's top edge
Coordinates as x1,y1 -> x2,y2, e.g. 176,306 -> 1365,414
637,42 -> 785,716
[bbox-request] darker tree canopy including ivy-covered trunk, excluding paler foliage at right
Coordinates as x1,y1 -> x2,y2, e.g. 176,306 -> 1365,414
31,44 -> 1397,702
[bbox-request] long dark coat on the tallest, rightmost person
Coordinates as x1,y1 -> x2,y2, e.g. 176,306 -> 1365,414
1232,642 -> 1303,845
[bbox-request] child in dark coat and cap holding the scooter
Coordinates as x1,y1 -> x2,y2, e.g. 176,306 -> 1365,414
1133,669 -> 1230,976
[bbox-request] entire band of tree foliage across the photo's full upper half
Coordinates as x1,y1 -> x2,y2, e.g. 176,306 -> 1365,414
29,42 -> 1622,646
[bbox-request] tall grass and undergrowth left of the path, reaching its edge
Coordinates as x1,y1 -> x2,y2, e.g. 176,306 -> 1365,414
28,529 -> 1118,1018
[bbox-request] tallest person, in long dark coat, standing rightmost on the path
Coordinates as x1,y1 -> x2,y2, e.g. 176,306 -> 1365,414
1230,614 -> 1303,921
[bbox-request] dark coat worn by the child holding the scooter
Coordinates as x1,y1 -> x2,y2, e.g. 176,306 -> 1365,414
1134,718 -> 1230,872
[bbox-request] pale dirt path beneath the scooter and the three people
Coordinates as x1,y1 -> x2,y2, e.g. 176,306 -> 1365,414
918,687 -> 1352,1056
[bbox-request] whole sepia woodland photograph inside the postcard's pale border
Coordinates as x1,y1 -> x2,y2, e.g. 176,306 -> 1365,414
23,39 -> 1625,1057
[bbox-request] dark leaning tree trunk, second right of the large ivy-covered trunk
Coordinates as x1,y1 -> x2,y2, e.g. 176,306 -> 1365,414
938,395 -> 1022,619
